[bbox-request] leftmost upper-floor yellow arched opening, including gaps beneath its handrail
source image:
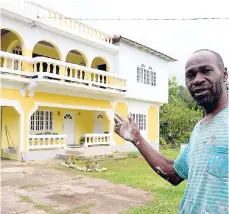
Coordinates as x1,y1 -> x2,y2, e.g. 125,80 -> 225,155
1,28 -> 24,69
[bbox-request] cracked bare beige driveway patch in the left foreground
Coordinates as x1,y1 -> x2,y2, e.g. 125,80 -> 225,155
1,160 -> 151,214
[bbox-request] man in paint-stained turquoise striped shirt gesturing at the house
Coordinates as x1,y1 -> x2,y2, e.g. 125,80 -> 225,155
114,49 -> 228,214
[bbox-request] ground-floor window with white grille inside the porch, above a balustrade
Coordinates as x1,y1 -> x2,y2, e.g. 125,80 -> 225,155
30,111 -> 53,131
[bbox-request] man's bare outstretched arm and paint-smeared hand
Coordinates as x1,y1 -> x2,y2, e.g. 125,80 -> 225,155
114,114 -> 184,186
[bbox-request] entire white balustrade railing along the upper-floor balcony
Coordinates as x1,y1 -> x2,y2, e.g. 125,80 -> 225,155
0,51 -> 126,92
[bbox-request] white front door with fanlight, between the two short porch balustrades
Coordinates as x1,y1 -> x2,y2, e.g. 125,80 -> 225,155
64,112 -> 76,145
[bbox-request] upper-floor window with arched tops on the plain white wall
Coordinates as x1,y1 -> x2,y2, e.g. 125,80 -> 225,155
137,64 -> 156,86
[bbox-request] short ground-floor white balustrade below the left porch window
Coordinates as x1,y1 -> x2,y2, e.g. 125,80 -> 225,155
29,134 -> 66,150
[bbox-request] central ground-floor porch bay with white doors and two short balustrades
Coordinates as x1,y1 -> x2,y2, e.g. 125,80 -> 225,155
29,106 -> 112,151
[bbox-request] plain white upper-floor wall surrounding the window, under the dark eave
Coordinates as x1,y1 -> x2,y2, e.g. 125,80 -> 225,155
119,42 -> 169,103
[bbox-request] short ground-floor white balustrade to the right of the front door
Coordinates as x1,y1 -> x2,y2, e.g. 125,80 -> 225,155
83,134 -> 111,147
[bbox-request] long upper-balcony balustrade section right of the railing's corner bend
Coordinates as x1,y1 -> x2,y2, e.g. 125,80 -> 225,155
33,57 -> 126,91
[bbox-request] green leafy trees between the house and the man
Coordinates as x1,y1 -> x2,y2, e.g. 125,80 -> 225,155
160,77 -> 203,148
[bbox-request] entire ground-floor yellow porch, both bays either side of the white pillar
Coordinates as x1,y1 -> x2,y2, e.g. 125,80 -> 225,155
1,103 -> 113,159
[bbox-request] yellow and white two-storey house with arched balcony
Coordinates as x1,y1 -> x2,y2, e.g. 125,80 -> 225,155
0,1 -> 175,160
